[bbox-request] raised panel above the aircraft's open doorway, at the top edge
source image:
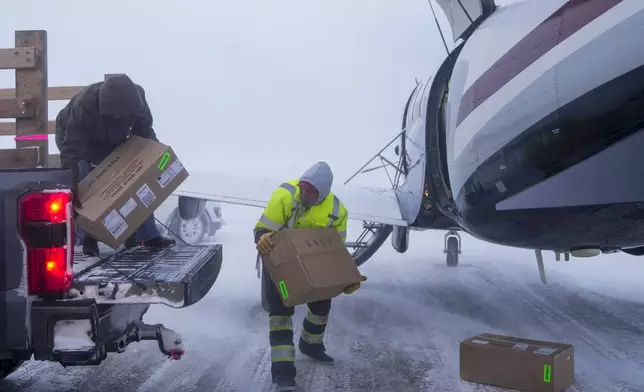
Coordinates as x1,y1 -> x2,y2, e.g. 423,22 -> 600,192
436,0 -> 496,42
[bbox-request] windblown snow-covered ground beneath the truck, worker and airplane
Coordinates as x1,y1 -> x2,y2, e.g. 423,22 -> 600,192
0,205 -> 644,392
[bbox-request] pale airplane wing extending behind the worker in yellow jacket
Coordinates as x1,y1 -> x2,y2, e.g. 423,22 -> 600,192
173,172 -> 407,226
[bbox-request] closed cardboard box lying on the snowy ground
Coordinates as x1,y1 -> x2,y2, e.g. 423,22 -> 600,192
460,334 -> 575,392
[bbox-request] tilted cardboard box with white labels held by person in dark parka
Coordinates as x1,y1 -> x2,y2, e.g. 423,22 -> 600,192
76,136 -> 188,249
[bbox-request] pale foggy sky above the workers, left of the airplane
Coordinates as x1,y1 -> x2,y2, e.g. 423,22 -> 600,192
0,0 -> 512,185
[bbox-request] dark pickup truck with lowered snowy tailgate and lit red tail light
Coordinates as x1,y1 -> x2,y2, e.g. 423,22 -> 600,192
0,168 -> 222,379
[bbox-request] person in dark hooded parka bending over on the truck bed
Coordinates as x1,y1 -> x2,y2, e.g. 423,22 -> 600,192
56,75 -> 175,256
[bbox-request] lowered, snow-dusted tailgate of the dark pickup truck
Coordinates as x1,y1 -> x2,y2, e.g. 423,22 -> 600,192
69,245 -> 223,308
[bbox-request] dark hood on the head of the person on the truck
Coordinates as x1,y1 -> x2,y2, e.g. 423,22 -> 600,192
98,75 -> 145,116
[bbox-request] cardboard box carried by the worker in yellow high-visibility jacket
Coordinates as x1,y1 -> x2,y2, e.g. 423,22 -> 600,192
262,228 -> 361,306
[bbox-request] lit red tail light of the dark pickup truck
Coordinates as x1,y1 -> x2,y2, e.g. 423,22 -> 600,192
18,190 -> 74,295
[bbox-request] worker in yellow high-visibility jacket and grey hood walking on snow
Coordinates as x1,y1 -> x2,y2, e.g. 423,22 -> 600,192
254,162 -> 367,391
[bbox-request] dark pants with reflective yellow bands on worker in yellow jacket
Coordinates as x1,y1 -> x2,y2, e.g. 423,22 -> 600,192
262,264 -> 331,380
